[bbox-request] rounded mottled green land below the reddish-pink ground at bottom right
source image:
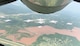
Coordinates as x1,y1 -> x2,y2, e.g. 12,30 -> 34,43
31,33 -> 80,46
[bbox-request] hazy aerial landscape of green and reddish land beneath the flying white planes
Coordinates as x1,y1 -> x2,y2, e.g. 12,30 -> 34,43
0,1 -> 80,46
